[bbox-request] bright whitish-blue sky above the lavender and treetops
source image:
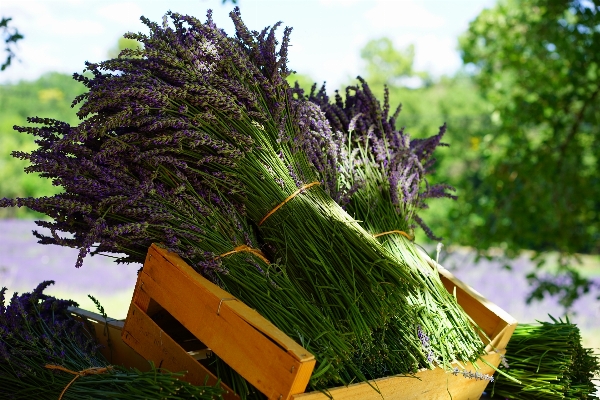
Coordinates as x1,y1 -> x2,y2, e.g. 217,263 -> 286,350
0,0 -> 495,87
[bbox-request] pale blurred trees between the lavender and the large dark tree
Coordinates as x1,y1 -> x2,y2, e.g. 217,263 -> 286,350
352,38 -> 494,245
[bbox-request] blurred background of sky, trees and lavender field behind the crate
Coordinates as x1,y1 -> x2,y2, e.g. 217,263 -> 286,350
0,0 -> 600,347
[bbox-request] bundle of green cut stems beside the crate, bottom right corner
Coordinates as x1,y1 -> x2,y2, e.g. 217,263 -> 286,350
486,317 -> 600,400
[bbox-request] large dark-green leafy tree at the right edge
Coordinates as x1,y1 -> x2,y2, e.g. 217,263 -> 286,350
460,0 -> 600,305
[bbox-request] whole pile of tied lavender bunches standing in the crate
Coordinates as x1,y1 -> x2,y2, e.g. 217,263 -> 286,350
0,9 -> 483,389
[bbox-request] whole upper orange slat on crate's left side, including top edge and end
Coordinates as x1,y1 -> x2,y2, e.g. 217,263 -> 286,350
134,245 -> 315,399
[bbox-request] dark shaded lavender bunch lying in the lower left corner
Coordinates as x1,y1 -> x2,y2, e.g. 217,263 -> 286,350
0,281 -> 222,400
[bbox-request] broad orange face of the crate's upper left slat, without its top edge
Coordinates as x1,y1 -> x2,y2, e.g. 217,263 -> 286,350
140,252 -> 314,399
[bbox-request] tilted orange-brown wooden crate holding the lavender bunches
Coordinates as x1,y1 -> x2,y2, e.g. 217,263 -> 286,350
116,245 -> 517,400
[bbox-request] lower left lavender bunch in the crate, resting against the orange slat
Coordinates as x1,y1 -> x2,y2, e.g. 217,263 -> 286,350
1,116 -> 358,390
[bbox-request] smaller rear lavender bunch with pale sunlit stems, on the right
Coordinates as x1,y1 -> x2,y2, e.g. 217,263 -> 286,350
295,78 -> 483,366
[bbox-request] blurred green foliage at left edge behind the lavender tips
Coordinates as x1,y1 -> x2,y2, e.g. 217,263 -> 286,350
0,73 -> 85,218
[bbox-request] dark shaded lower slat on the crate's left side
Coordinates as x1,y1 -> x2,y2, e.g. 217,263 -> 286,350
121,304 -> 239,400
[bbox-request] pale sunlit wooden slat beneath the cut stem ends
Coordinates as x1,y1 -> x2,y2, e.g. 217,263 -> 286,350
293,353 -> 500,400
